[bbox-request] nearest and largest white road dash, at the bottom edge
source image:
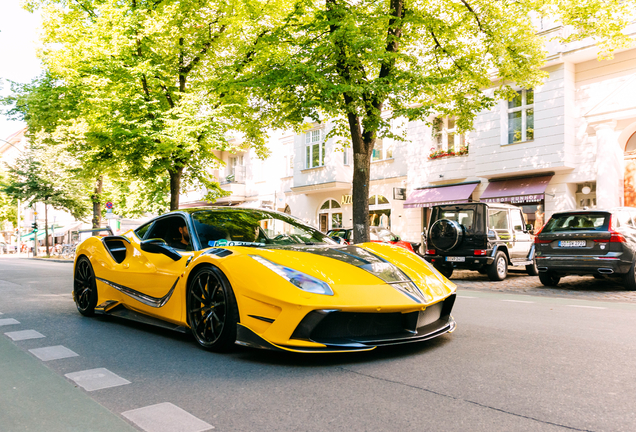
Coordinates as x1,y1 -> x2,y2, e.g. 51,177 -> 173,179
121,402 -> 214,432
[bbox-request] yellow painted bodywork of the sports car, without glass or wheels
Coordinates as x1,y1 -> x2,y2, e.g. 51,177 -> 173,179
76,231 -> 456,351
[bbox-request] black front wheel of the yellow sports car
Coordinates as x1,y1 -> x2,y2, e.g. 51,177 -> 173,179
187,266 -> 239,352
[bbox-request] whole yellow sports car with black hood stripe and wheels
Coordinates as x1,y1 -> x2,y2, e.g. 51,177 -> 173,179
73,207 -> 456,352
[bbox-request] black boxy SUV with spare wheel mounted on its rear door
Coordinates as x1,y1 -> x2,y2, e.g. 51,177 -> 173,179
425,203 -> 538,281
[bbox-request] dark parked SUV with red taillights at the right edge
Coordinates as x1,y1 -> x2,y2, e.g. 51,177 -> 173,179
534,207 -> 636,290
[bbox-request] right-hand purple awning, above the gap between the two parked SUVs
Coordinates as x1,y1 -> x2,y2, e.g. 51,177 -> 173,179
479,175 -> 552,204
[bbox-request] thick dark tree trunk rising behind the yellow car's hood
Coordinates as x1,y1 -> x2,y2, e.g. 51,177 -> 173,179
347,114 -> 375,243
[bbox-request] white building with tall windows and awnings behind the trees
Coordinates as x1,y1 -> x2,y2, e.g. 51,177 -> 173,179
179,26 -> 636,246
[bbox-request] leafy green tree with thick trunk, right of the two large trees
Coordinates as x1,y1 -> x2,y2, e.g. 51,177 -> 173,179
243,0 -> 636,242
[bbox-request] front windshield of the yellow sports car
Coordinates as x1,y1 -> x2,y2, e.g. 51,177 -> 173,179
192,209 -> 336,248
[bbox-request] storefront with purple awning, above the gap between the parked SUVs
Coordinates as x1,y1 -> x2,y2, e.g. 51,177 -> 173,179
479,174 -> 553,231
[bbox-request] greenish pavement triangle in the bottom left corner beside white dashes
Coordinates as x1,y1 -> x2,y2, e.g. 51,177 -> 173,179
0,332 -> 137,432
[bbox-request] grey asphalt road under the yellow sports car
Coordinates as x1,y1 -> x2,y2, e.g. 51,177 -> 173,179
0,258 -> 636,432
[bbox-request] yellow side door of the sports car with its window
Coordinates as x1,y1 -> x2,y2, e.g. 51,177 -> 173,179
101,215 -> 193,312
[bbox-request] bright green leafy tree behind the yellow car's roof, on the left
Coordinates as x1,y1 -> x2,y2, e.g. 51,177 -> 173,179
18,0 -> 284,209
